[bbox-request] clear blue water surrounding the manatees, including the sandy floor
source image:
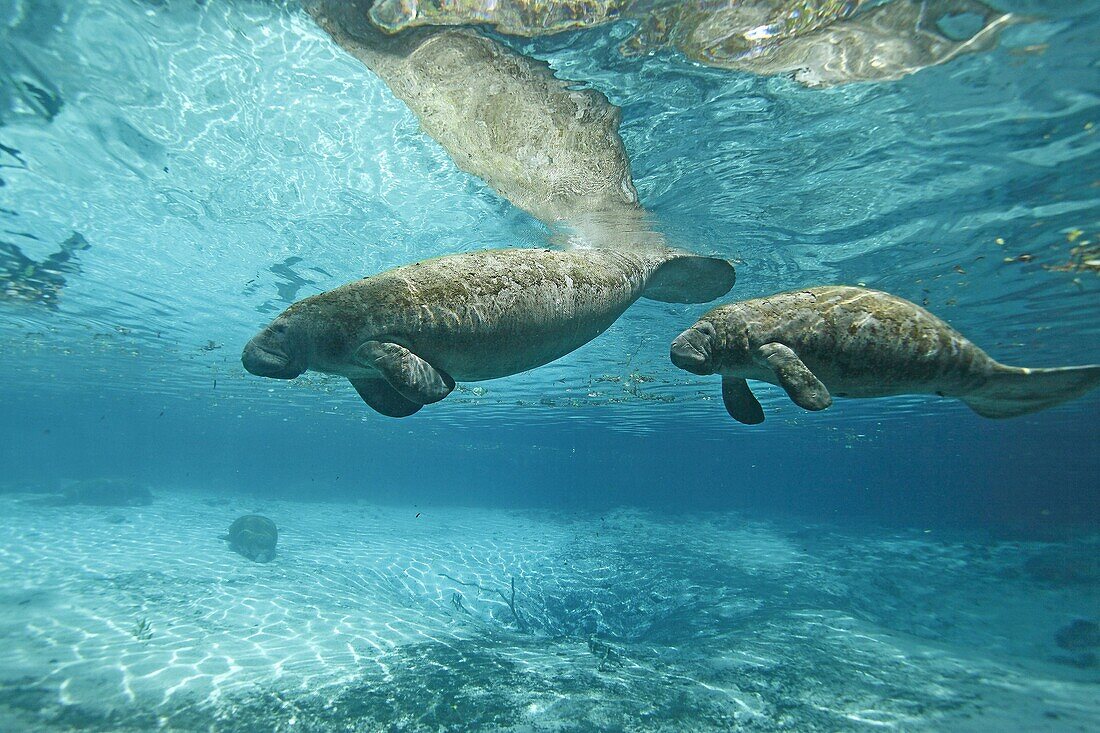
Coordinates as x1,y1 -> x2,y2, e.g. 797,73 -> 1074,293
0,0 -> 1100,731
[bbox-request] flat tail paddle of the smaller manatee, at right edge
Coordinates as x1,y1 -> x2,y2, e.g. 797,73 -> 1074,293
963,364 -> 1100,418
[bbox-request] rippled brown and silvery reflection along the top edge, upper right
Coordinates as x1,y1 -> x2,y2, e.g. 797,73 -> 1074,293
370,0 -> 1019,86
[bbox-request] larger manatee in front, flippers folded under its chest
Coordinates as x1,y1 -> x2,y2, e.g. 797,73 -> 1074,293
242,248 -> 735,417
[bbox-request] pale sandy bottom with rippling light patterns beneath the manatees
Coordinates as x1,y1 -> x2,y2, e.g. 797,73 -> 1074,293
0,490 -> 1100,731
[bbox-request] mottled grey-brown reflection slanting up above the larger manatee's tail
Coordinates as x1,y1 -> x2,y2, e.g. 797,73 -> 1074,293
303,0 -> 641,225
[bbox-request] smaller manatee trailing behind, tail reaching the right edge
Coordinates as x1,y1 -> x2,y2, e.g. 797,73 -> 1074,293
671,285 -> 1100,425
